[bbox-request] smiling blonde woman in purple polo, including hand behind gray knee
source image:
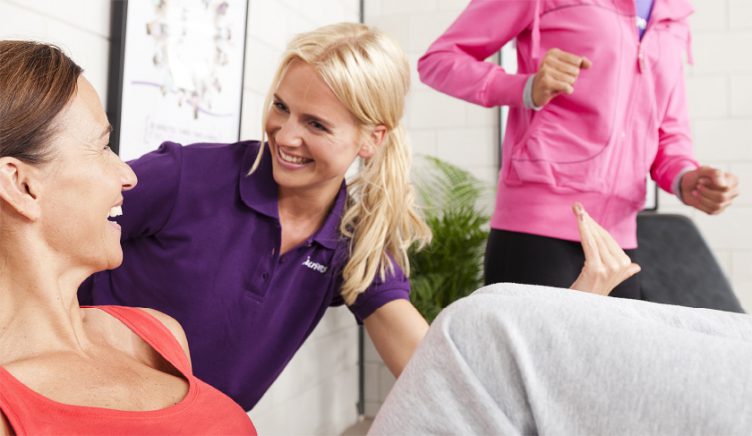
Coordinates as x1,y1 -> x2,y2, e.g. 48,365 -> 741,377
81,23 -> 636,410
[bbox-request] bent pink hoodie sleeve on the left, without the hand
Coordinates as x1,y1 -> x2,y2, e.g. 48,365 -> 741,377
418,0 -> 535,107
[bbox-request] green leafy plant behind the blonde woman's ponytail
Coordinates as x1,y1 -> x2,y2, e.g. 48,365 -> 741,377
409,156 -> 489,322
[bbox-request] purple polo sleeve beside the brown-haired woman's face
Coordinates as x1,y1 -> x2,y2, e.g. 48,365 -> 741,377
117,142 -> 183,240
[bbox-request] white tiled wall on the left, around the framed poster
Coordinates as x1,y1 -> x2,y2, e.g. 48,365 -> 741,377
0,0 -> 359,435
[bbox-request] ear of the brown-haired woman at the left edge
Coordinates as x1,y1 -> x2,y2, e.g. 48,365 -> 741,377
0,156 -> 41,221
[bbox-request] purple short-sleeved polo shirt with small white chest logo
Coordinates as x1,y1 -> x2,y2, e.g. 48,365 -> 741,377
79,141 -> 409,410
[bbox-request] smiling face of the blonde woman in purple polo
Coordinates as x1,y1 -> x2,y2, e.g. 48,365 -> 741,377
265,61 -> 373,199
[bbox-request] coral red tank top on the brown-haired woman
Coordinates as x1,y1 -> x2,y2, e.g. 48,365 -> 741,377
0,306 -> 256,435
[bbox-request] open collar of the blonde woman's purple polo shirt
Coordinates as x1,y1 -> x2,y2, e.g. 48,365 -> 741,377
239,143 -> 347,250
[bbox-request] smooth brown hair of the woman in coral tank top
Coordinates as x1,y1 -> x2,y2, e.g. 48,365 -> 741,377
0,41 -> 82,163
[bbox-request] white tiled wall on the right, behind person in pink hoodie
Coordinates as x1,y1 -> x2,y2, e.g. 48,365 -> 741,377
365,0 -> 752,414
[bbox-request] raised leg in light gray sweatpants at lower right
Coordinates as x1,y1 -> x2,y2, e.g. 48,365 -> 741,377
370,284 -> 752,435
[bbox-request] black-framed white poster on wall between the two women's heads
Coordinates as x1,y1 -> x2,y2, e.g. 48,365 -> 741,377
107,0 -> 248,160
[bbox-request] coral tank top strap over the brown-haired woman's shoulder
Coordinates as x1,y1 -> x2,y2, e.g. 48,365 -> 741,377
93,306 -> 192,377
